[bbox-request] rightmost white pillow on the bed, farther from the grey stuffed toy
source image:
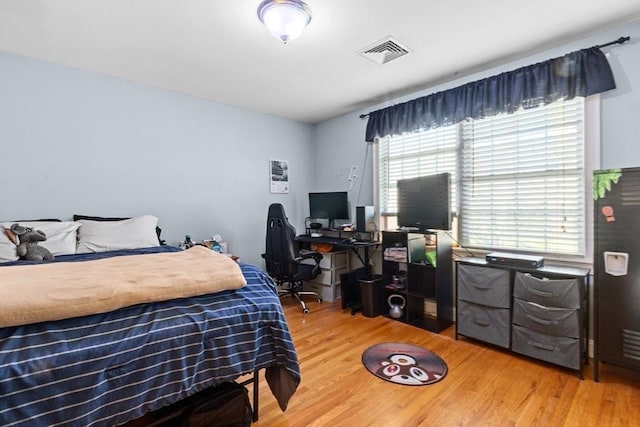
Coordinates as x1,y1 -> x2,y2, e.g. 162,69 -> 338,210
76,215 -> 160,254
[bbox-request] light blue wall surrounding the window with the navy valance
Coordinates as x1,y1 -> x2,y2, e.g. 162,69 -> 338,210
314,18 -> 640,205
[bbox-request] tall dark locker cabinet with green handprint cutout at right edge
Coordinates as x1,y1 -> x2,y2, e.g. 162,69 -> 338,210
593,168 -> 640,381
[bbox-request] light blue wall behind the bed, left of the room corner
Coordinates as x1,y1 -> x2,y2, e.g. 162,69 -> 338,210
0,53 -> 314,265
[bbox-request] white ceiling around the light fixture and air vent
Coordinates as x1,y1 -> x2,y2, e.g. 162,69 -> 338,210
0,0 -> 640,123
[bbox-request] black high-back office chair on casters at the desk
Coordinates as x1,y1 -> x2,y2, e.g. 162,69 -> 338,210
262,203 -> 322,314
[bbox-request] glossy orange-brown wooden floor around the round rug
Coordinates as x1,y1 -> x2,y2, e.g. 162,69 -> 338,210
241,298 -> 640,427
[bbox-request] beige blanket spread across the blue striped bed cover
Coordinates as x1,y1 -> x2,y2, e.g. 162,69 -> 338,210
0,246 -> 246,327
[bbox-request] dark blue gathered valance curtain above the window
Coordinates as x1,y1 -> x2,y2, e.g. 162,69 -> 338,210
365,46 -> 616,142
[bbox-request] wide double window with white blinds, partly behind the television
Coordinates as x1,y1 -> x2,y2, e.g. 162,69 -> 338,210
378,97 -> 591,256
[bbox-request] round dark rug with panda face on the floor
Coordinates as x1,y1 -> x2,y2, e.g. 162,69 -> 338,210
362,342 -> 447,386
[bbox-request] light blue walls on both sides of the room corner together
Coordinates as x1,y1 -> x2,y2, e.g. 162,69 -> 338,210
0,23 -> 640,264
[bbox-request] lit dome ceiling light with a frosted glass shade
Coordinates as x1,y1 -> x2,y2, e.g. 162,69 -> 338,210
258,0 -> 311,44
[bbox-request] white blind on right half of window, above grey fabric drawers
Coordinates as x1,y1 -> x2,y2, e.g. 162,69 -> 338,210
459,98 -> 585,255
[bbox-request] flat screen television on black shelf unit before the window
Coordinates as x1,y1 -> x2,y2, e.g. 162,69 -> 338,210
397,172 -> 451,232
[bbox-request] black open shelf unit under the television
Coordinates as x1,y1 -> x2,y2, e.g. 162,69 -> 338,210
382,231 -> 453,332
